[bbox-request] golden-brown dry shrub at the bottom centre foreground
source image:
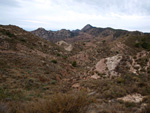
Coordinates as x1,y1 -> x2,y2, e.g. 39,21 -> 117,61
41,92 -> 90,113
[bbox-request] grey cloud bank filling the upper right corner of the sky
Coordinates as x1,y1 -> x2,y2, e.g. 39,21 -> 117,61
74,0 -> 150,15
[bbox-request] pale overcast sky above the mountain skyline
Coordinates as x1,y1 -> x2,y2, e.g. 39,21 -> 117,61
0,0 -> 150,32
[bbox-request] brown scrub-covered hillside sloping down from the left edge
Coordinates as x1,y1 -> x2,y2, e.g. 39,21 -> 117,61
0,26 -> 82,100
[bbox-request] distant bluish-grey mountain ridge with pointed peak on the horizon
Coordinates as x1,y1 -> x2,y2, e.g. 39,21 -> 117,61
31,24 -> 130,42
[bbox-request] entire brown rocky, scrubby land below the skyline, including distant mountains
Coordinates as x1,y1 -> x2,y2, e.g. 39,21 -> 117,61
0,24 -> 150,113
